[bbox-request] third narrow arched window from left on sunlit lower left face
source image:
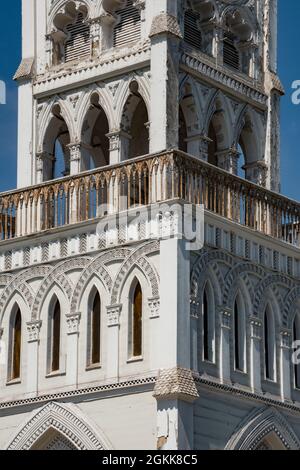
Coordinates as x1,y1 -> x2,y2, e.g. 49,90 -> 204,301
89,291 -> 101,366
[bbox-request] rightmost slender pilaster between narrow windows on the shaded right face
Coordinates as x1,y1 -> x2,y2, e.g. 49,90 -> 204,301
280,330 -> 292,401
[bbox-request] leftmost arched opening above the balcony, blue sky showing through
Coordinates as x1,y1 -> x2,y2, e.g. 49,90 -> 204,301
43,105 -> 70,181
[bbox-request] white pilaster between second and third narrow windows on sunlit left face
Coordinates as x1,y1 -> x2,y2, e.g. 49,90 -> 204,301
66,313 -> 81,386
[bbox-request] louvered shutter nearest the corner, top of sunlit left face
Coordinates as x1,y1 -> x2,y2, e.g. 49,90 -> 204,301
114,0 -> 141,47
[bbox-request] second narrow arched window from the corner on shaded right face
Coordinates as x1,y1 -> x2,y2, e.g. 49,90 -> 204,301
234,294 -> 246,372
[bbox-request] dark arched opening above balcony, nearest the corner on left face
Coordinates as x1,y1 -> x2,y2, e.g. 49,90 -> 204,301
121,81 -> 149,160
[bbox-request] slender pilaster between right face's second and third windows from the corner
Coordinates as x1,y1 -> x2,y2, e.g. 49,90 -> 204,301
250,317 -> 262,393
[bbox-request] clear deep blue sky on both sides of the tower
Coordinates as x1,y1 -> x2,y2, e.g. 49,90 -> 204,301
0,0 -> 300,200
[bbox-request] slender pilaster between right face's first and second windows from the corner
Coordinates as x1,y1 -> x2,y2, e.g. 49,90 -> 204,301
219,308 -> 232,383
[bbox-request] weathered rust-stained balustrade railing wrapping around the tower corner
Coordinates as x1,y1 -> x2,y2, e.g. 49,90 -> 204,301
0,151 -> 300,245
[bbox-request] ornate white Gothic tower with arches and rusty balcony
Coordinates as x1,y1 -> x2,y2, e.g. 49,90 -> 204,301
0,0 -> 300,450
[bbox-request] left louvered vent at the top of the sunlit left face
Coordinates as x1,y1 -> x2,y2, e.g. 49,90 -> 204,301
65,13 -> 91,62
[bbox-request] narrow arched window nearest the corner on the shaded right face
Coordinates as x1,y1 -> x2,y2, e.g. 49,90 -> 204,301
202,283 -> 215,362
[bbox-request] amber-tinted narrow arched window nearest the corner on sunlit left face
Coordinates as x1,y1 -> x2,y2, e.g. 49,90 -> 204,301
129,281 -> 143,358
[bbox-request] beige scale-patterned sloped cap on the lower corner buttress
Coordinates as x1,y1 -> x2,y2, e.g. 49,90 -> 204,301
153,367 -> 199,403
